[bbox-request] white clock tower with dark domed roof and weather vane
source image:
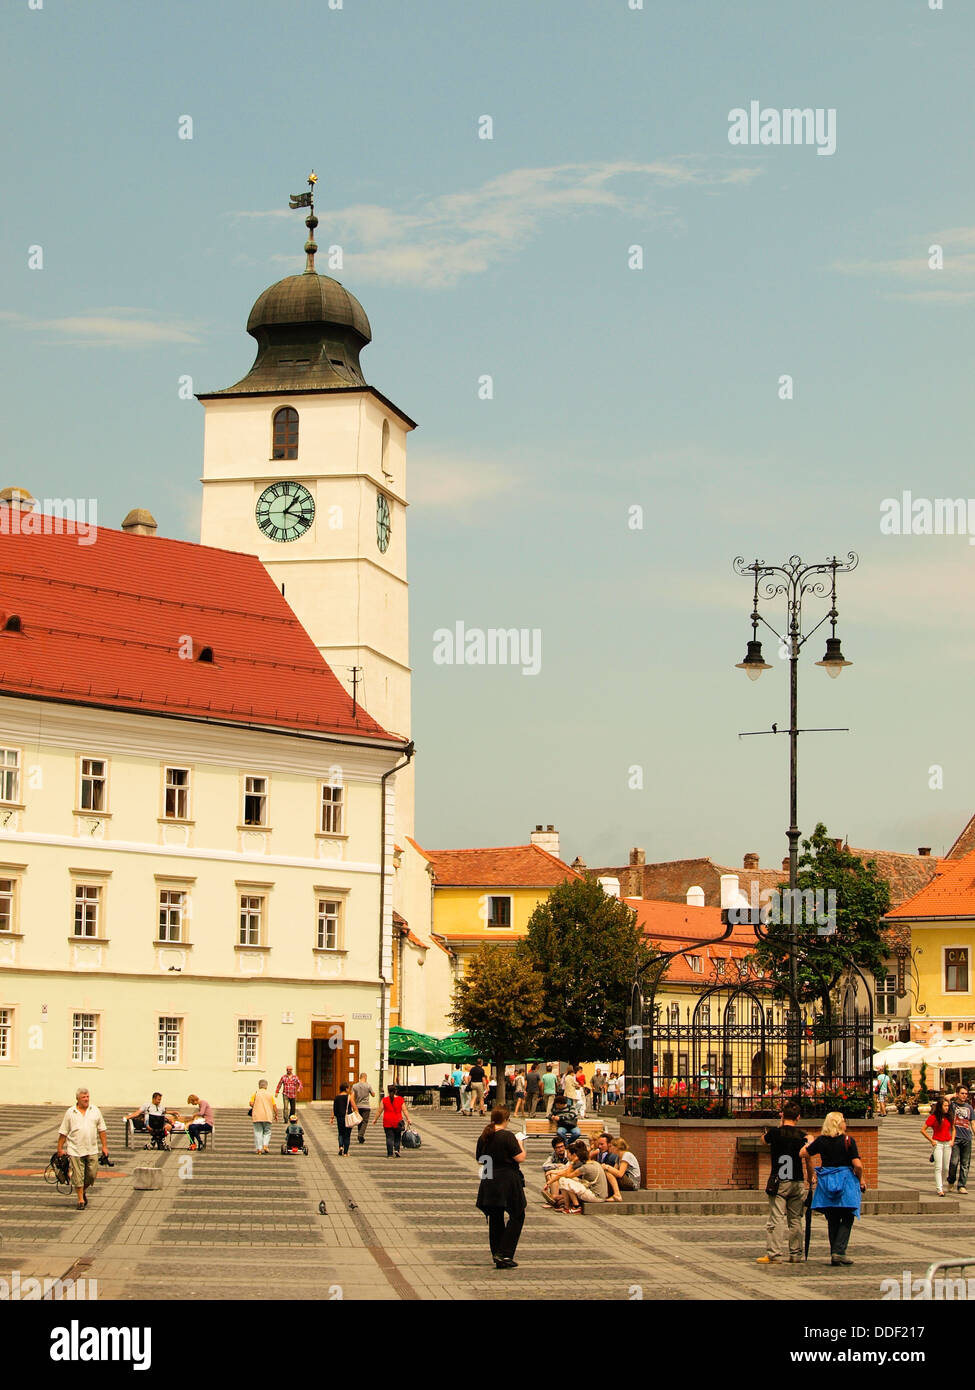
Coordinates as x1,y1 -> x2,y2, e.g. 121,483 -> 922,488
198,181 -> 414,835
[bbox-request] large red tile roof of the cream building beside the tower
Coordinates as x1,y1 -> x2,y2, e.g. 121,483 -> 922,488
0,523 -> 395,738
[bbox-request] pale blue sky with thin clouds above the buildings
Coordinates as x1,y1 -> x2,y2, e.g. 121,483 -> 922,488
0,0 -> 975,865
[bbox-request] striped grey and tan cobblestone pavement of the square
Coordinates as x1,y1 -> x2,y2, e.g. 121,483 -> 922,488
0,1106 -> 975,1301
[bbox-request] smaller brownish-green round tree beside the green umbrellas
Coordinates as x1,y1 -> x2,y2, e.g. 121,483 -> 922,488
451,941 -> 551,1105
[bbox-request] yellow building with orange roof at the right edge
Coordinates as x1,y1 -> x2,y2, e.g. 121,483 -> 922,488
886,851 -> 975,1043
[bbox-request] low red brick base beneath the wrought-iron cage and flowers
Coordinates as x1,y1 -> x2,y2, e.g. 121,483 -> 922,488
619,1116 -> 878,1190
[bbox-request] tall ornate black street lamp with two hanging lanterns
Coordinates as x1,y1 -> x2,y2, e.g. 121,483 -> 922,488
734,550 -> 858,1087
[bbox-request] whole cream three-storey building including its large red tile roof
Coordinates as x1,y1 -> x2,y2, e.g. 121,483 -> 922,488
0,502 -> 408,1105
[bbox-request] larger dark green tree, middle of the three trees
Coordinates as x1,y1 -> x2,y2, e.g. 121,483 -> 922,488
526,878 -> 656,1062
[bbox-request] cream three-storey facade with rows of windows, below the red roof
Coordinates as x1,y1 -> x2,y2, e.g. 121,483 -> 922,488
0,689 -> 396,1106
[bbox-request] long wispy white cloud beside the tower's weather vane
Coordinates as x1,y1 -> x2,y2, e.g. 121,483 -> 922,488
238,157 -> 759,289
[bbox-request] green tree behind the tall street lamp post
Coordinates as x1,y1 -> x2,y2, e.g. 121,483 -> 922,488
752,821 -> 890,1004
